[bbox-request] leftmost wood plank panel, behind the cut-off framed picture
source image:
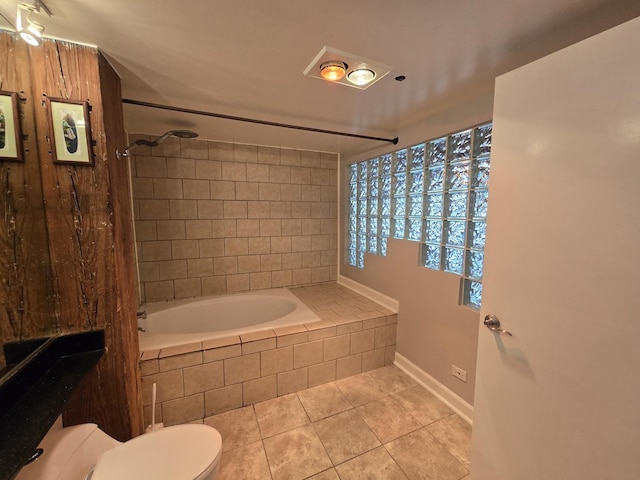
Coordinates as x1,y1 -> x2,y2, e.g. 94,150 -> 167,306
0,32 -> 58,365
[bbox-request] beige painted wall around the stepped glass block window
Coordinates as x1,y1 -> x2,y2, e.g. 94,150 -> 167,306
340,93 -> 493,405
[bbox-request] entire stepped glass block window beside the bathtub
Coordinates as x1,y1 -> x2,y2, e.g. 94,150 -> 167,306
347,123 -> 492,308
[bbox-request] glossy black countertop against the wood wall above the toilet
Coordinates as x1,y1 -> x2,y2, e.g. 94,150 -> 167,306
0,331 -> 104,480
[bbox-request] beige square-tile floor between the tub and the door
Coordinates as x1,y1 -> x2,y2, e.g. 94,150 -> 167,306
204,365 -> 471,480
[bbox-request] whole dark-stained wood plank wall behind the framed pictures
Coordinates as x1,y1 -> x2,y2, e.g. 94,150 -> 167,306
0,32 -> 142,440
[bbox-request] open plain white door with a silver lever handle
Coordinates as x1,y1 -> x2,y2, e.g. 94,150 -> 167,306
471,18 -> 640,480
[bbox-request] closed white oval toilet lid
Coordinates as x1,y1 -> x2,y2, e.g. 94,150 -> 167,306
91,424 -> 222,480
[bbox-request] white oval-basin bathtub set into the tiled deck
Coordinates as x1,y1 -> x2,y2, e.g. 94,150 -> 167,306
138,288 -> 320,351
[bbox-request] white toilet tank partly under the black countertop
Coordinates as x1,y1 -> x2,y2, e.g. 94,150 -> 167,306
15,423 -> 120,480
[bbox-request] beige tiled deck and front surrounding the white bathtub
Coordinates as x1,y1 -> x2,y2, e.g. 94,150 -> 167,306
140,283 -> 398,426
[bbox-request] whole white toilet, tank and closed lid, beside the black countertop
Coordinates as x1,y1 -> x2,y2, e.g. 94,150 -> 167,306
16,423 -> 222,480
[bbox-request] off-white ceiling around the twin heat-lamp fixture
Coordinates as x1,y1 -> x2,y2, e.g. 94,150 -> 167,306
0,0 -> 640,154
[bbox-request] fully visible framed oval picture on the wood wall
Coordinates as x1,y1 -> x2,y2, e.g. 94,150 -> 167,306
47,97 -> 93,165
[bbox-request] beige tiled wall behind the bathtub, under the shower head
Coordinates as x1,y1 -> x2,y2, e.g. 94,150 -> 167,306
130,134 -> 338,302
